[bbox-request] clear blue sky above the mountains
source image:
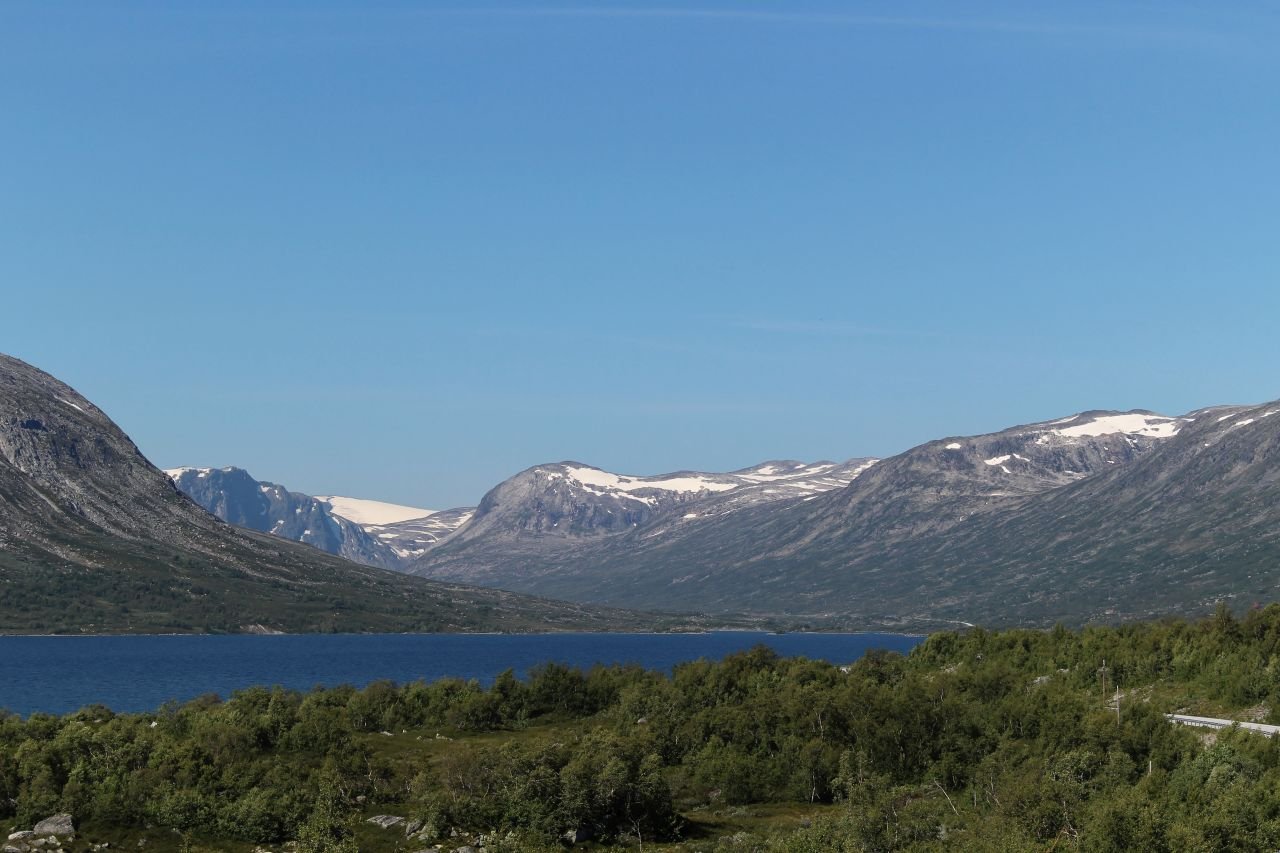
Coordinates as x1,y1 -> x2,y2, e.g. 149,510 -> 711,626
0,0 -> 1280,507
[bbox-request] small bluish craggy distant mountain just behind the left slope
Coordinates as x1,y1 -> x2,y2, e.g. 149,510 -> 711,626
165,467 -> 402,570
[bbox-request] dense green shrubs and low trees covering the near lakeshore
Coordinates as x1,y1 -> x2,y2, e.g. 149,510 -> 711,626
0,606 -> 1280,853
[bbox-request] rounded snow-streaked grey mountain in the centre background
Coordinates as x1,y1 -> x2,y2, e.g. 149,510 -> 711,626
408,459 -> 874,588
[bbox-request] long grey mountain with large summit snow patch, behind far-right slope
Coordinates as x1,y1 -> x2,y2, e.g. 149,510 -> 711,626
532,411 -> 1184,620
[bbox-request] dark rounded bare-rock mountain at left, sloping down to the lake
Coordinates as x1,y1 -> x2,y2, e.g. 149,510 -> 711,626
0,356 -> 670,633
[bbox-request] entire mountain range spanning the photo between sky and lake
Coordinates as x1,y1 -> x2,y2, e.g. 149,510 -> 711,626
12,345 -> 1280,631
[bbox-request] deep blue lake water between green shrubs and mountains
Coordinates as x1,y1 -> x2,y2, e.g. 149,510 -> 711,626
0,631 -> 923,716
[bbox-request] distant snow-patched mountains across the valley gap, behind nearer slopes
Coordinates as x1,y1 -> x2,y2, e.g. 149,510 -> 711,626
165,459 -> 876,573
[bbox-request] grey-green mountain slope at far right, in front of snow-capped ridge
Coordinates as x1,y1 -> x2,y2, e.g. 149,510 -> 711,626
865,403 -> 1280,622
